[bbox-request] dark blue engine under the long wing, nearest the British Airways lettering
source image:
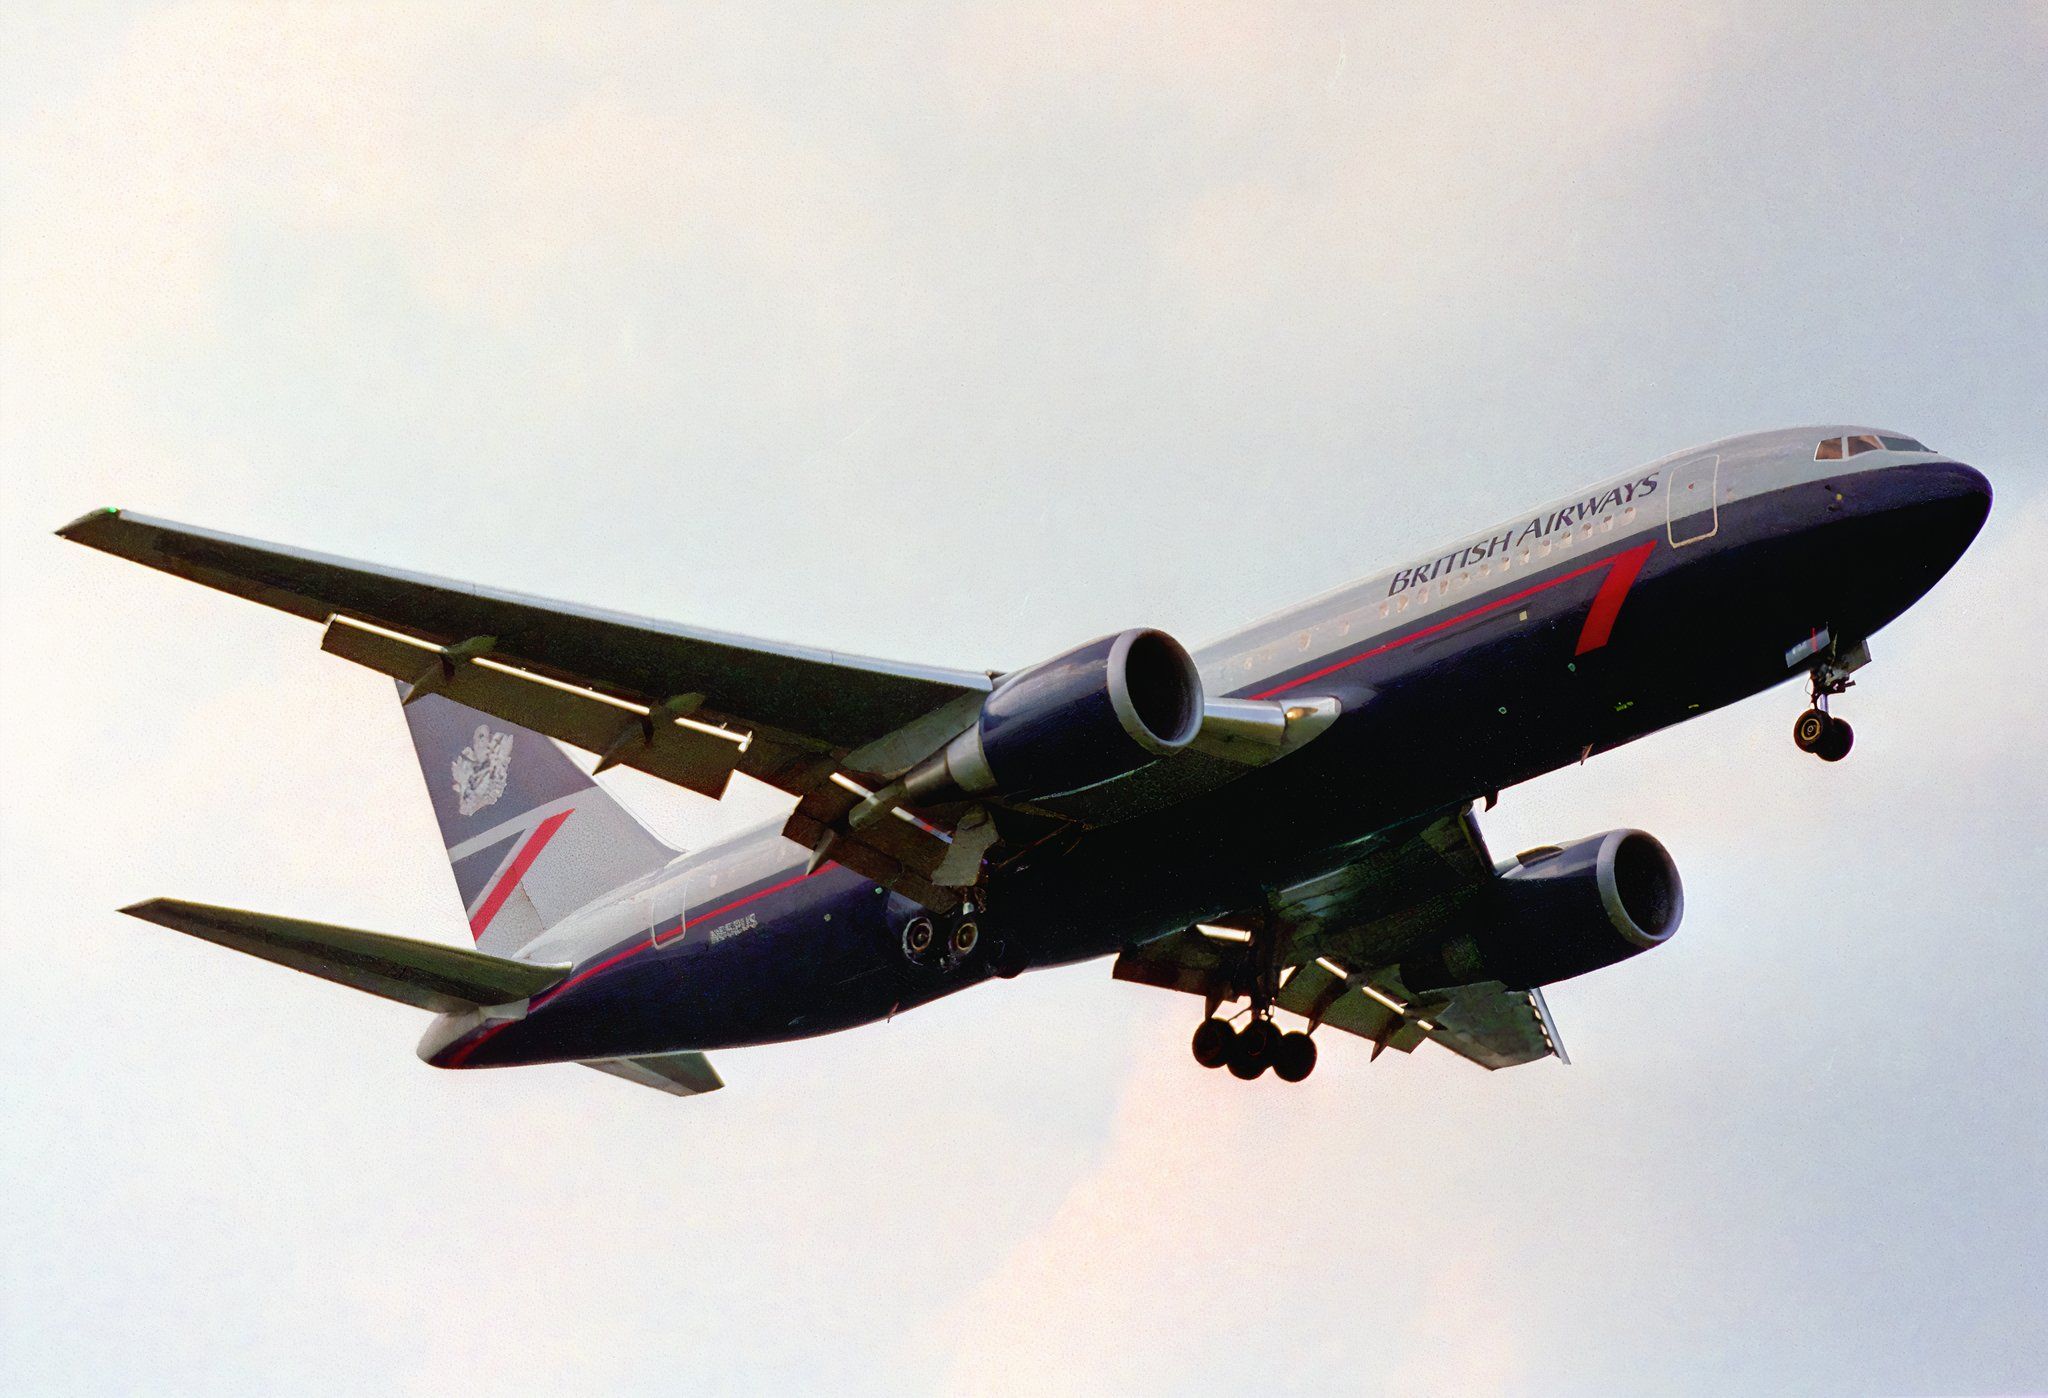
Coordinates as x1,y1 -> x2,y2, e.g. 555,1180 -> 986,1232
903,630 -> 1202,804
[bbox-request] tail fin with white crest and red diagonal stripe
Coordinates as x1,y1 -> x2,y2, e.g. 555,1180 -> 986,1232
399,686 -> 676,956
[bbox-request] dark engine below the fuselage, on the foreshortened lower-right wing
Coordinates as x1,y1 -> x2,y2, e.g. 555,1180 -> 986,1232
1401,831 -> 1686,991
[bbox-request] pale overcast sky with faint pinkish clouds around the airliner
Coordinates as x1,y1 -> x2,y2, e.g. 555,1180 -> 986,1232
0,0 -> 2048,1394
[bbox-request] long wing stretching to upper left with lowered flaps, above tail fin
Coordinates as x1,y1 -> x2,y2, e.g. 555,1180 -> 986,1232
57,510 -> 991,909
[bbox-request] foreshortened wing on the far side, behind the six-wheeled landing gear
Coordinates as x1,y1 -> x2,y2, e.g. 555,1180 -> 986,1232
1114,806 -> 1569,1068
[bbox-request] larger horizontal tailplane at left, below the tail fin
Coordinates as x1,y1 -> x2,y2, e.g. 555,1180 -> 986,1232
121,899 -> 569,1013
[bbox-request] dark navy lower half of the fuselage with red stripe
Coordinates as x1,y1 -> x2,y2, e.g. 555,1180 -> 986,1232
434,446 -> 1991,1066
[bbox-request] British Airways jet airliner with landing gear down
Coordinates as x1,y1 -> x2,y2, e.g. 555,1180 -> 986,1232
57,426 -> 1991,1095
